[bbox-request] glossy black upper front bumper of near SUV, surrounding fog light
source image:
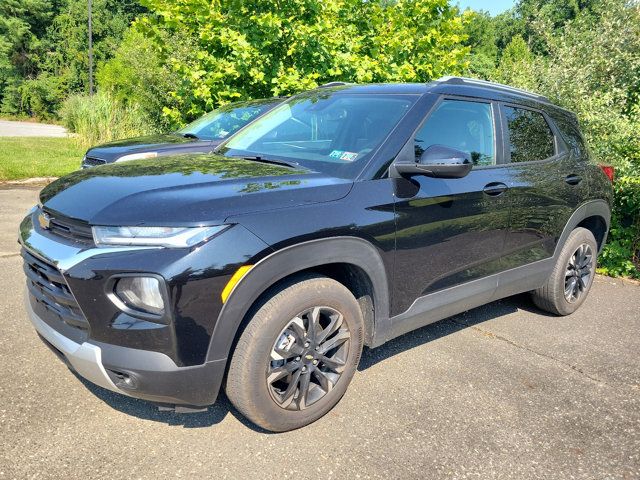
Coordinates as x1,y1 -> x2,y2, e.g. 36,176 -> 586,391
20,208 -> 270,367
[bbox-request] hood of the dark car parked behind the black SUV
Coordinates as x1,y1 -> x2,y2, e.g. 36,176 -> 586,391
87,134 -> 212,162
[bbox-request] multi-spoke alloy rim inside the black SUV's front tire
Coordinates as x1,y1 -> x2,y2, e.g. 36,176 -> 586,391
266,306 -> 351,410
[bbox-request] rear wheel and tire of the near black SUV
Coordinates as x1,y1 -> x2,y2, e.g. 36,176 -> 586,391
532,227 -> 598,315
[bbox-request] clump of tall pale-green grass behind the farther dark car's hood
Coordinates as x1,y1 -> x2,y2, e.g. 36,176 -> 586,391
60,92 -> 154,148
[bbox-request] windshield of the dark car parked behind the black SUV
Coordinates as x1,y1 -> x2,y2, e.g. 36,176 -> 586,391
177,101 -> 279,140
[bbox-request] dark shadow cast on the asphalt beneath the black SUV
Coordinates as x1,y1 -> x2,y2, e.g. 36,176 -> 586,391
74,294 -> 545,434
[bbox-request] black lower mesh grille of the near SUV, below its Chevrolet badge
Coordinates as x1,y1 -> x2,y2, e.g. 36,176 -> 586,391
21,248 -> 89,330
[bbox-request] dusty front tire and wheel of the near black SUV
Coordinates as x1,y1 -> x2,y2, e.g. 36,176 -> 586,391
225,275 -> 364,432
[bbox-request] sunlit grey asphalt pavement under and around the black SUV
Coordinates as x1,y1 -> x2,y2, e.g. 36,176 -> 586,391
0,190 -> 640,480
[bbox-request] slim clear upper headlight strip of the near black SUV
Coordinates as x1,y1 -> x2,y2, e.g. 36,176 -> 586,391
92,225 -> 229,248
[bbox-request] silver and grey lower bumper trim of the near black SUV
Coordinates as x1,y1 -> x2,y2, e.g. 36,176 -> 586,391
25,295 -> 226,406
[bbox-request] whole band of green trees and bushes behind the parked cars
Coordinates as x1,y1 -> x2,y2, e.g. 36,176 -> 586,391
0,0 -> 640,277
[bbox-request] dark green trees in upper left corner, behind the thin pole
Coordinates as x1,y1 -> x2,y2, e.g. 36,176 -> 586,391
0,0 -> 144,118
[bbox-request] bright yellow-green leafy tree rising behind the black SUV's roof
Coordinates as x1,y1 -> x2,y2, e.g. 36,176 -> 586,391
126,0 -> 468,123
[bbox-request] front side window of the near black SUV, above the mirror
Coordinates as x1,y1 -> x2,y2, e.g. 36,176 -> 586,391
415,100 -> 496,165
